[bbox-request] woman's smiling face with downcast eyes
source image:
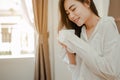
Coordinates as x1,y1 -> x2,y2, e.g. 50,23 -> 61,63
64,0 -> 90,26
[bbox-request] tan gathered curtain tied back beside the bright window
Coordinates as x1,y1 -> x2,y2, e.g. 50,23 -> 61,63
33,0 -> 51,80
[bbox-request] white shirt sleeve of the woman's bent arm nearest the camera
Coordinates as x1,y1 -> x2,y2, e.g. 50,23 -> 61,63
59,20 -> 120,79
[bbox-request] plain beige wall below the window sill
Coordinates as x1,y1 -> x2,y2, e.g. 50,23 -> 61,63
0,57 -> 34,80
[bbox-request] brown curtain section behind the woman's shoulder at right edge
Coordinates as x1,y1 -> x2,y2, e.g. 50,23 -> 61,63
108,0 -> 120,32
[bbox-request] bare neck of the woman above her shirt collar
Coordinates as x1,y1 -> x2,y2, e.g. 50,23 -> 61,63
85,14 -> 100,30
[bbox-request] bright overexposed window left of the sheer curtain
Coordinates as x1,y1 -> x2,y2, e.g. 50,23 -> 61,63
0,0 -> 35,56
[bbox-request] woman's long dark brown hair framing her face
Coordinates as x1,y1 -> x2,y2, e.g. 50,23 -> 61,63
58,0 -> 99,37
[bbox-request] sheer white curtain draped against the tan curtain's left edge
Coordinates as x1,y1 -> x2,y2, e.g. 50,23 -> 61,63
20,0 -> 39,53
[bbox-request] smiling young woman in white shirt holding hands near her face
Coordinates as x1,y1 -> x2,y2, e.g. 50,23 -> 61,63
58,0 -> 120,80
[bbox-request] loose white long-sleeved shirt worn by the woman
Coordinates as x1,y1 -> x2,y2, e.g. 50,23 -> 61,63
58,17 -> 120,80
